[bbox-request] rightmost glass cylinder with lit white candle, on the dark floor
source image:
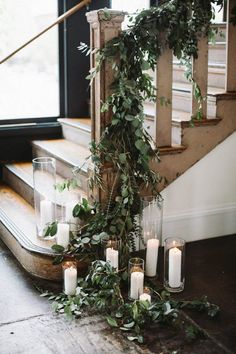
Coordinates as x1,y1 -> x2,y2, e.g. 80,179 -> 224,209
164,237 -> 185,293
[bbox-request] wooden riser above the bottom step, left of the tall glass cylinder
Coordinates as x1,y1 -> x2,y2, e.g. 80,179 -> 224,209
3,166 -> 34,206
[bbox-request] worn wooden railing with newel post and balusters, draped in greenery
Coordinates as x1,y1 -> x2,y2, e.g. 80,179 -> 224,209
88,0 -> 236,151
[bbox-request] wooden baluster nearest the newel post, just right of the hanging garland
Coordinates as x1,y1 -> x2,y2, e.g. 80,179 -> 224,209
155,49 -> 173,147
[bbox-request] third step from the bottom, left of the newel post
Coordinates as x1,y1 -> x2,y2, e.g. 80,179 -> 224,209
32,139 -> 90,193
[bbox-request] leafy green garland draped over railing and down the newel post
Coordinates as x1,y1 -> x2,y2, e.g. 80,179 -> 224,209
46,0 -> 229,267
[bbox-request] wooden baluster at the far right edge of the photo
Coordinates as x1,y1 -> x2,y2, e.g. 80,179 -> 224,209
225,0 -> 236,92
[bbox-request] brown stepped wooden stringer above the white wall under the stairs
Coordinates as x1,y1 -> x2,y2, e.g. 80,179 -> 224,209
152,94 -> 236,190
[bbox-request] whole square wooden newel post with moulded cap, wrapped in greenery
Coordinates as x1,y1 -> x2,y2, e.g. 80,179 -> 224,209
87,9 -> 125,203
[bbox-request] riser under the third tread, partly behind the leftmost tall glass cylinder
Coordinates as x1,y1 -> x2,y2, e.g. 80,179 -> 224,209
33,146 -> 88,193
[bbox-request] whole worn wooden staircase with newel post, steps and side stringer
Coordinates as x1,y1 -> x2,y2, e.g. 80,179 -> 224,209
0,4 -> 236,280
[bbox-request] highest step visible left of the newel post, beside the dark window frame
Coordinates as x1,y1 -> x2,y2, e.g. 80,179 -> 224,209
58,118 -> 91,148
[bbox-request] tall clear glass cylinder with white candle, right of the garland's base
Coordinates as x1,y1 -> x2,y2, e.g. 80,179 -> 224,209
140,196 -> 163,277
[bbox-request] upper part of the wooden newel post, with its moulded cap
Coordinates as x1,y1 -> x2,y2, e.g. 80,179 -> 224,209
86,9 -> 125,142
